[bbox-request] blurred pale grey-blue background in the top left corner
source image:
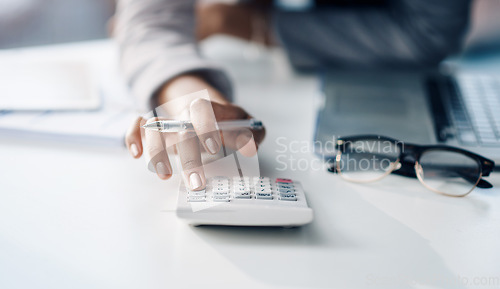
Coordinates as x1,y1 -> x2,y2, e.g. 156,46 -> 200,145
0,0 -> 115,49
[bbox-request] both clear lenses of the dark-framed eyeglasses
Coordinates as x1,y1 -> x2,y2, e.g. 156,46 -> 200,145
337,139 -> 481,196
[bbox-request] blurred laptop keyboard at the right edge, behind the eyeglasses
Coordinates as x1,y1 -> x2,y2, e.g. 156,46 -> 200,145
451,75 -> 500,146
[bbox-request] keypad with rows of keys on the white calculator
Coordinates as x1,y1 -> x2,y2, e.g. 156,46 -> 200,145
187,176 -> 297,202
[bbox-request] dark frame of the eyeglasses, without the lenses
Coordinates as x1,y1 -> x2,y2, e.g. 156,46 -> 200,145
328,135 -> 495,197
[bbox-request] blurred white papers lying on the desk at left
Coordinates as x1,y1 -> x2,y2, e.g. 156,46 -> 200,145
0,41 -> 139,146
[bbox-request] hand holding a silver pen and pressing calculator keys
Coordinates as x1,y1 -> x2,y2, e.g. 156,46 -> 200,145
126,75 -> 265,190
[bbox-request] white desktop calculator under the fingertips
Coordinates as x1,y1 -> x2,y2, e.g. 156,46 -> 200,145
177,176 -> 313,227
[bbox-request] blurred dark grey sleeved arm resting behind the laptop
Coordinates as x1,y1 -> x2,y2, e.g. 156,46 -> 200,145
275,0 -> 470,67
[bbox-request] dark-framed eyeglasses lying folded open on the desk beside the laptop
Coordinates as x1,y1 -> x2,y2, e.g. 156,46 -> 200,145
329,135 -> 495,197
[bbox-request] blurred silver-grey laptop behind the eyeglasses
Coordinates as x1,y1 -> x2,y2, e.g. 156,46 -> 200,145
314,70 -> 500,163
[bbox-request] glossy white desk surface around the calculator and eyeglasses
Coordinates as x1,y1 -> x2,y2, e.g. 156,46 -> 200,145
0,39 -> 500,289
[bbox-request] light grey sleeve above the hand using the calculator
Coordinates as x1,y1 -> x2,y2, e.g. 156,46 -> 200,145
115,0 -> 231,109
